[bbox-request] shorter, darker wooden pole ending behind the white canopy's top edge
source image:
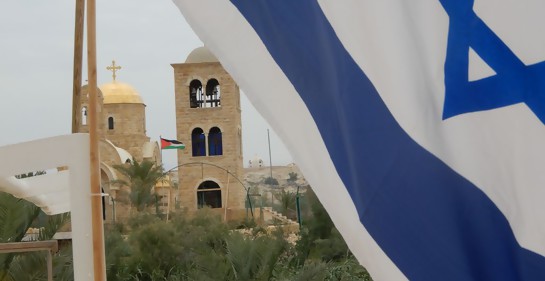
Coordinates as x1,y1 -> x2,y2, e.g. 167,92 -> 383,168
72,0 -> 85,134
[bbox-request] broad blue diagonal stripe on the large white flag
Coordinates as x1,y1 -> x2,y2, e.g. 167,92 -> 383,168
231,0 -> 545,280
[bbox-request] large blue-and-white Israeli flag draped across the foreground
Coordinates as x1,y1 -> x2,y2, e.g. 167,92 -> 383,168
174,0 -> 545,281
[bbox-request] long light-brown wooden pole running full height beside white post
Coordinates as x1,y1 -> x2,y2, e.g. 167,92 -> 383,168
87,0 -> 106,281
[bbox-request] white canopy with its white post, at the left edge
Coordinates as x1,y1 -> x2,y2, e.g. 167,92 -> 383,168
0,134 -> 96,281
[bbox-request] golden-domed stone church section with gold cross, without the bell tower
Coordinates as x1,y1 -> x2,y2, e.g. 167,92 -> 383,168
76,61 -> 161,222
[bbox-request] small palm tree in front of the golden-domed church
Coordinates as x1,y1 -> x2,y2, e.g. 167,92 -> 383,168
113,159 -> 165,212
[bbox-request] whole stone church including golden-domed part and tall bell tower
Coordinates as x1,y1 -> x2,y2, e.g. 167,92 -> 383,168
72,47 -> 248,222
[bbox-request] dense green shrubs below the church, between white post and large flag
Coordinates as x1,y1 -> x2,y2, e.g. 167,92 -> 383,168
99,199 -> 371,281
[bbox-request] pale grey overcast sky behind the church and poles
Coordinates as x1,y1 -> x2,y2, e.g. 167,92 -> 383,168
0,0 -> 292,169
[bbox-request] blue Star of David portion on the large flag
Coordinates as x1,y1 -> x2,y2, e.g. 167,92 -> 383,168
439,0 -> 545,124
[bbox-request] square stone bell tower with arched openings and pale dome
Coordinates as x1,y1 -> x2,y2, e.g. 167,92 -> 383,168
172,47 -> 246,219
